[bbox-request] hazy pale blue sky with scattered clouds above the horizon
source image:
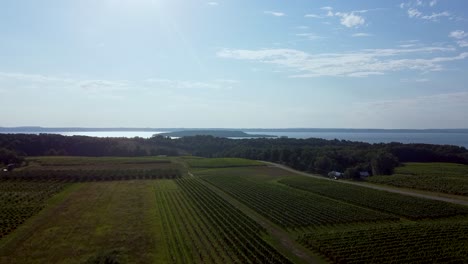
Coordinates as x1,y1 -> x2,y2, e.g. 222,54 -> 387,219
0,0 -> 468,129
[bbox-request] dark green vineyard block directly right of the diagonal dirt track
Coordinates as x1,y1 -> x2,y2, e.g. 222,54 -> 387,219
202,175 -> 398,228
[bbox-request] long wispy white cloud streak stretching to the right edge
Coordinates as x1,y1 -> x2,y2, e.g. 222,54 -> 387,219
217,47 -> 468,77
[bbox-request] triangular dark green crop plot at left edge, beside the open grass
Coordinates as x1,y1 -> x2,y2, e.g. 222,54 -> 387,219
0,181 -> 66,239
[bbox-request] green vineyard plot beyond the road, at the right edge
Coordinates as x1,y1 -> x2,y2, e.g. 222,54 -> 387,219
368,163 -> 468,196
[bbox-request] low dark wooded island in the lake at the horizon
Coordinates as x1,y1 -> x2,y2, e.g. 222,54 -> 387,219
157,130 -> 277,138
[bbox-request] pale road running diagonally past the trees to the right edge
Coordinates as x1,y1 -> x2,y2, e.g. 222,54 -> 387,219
262,161 -> 468,206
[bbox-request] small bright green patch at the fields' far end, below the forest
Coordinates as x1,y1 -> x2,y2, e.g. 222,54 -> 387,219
185,158 -> 265,168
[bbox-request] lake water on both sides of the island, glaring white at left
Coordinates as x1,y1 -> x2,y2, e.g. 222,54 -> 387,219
0,131 -> 468,148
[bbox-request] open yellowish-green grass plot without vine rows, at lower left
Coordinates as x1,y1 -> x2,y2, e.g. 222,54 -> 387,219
0,180 -> 162,263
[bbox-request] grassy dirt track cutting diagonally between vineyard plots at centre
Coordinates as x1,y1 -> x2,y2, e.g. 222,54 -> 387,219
195,174 -> 325,263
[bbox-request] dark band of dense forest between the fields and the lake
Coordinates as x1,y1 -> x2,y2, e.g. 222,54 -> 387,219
0,134 -> 468,177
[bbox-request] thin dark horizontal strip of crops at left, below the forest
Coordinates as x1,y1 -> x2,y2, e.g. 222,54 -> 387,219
0,168 -> 181,182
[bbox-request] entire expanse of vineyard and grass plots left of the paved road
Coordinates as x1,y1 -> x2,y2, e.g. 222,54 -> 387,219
0,157 -> 468,264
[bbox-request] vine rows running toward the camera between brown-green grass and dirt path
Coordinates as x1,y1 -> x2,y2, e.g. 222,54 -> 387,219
155,178 -> 291,264
